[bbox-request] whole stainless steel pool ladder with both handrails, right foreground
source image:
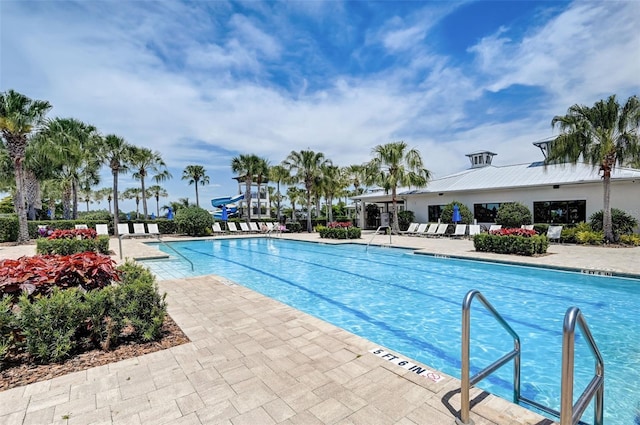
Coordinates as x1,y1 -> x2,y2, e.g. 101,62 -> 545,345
456,290 -> 604,425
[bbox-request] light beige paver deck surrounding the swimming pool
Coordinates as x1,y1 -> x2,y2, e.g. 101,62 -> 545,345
0,233 -> 640,425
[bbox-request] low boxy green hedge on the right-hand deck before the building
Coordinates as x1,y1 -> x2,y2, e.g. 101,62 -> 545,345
473,233 -> 549,256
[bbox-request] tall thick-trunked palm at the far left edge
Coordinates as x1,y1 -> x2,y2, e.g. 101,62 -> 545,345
0,90 -> 51,243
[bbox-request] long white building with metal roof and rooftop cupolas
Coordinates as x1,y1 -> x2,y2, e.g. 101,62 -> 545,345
352,146 -> 640,227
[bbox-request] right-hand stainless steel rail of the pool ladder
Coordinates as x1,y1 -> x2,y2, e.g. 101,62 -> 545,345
560,307 -> 604,425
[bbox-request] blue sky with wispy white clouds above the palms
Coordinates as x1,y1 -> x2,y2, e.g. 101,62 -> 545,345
0,0 -> 640,210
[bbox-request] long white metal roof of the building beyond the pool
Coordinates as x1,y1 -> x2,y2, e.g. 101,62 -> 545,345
353,162 -> 640,199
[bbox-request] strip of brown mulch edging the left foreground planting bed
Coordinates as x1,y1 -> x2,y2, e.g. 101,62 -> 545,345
0,315 -> 189,391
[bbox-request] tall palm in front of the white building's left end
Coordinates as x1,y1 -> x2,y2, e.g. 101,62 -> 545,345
367,141 -> 431,234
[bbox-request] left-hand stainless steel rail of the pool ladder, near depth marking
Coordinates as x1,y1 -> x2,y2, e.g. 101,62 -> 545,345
456,289 -> 520,425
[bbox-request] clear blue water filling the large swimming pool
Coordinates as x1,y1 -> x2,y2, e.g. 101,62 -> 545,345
145,238 -> 640,425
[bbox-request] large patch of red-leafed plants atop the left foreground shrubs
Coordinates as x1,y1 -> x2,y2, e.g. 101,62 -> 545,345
0,252 -> 120,295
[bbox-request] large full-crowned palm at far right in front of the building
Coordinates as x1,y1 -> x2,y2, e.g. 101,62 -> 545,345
546,95 -> 640,242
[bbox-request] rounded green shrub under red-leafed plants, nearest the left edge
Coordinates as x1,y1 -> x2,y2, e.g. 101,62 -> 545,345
18,288 -> 85,363
